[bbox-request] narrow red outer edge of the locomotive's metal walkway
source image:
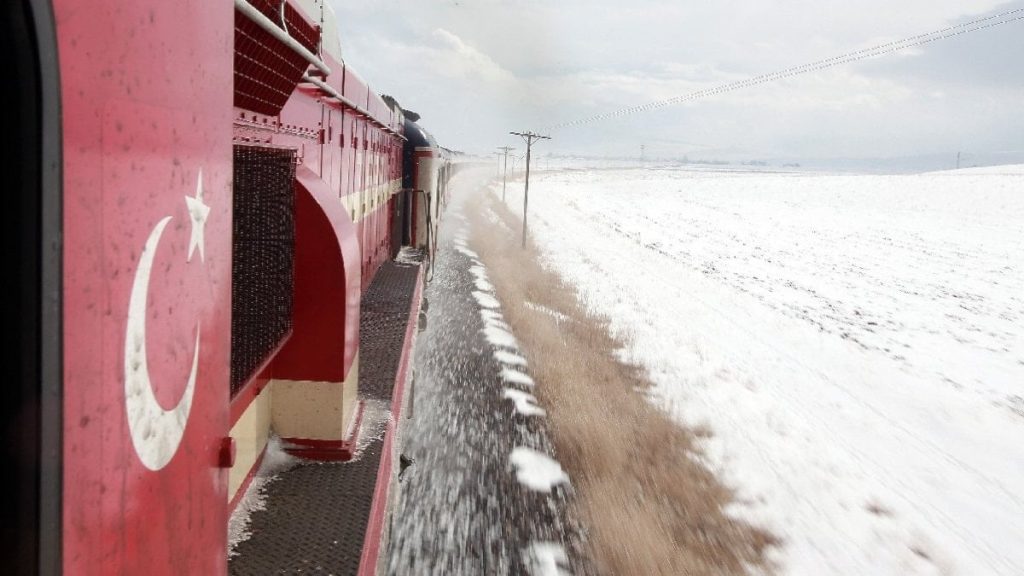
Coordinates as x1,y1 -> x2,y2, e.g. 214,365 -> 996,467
358,266 -> 423,576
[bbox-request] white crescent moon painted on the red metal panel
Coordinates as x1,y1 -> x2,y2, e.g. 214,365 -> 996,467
125,216 -> 200,470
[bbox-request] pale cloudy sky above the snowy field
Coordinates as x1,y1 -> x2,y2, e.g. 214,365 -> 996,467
329,0 -> 1024,165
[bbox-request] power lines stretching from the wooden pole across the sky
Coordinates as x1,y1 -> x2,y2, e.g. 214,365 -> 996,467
548,8 -> 1024,130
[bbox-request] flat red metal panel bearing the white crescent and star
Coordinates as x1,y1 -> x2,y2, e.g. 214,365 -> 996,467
53,0 -> 233,575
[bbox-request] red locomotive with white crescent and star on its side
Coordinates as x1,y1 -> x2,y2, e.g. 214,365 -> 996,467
7,0 -> 454,574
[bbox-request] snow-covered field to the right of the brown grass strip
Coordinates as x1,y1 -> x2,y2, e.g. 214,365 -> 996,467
498,163 -> 1024,576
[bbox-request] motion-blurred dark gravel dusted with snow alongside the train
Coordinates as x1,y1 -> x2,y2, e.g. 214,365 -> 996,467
389,170 -> 591,575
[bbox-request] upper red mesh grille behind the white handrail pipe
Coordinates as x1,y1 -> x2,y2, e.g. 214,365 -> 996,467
234,0 -> 319,116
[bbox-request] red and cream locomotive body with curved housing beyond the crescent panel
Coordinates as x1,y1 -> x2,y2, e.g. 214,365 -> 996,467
223,0 -> 398,500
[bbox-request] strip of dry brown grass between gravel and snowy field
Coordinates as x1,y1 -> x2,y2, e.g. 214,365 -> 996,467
466,186 -> 778,575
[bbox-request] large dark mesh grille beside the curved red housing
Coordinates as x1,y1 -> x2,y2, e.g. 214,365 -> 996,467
231,146 -> 295,395
